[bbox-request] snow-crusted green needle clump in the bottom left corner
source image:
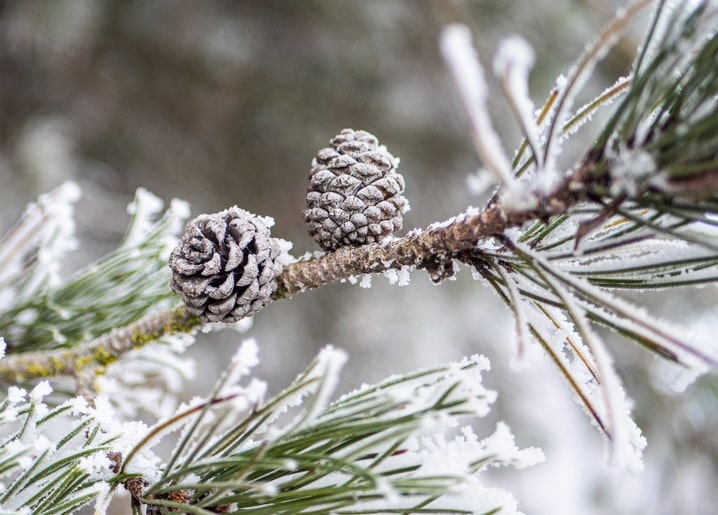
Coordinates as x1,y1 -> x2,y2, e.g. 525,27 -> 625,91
0,382 -> 155,513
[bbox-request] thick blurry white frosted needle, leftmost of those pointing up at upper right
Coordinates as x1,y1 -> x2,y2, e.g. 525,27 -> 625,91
440,24 -> 514,184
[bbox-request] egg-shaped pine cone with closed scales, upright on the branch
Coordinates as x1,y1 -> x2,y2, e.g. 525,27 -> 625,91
304,129 -> 409,250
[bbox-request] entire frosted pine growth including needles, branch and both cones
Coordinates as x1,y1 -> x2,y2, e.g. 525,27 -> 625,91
0,0 -> 718,514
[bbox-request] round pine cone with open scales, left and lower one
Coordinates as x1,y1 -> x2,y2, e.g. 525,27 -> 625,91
169,206 -> 282,322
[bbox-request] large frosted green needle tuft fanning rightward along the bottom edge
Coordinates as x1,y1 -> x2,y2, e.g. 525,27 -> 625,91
129,344 -> 542,513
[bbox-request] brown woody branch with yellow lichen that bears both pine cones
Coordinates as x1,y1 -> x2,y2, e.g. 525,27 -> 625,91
0,164 -> 596,383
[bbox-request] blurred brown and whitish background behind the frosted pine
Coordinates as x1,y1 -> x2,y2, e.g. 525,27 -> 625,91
0,0 -> 718,514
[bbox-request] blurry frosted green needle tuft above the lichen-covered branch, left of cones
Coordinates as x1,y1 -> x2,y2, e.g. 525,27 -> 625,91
0,183 -> 187,351
